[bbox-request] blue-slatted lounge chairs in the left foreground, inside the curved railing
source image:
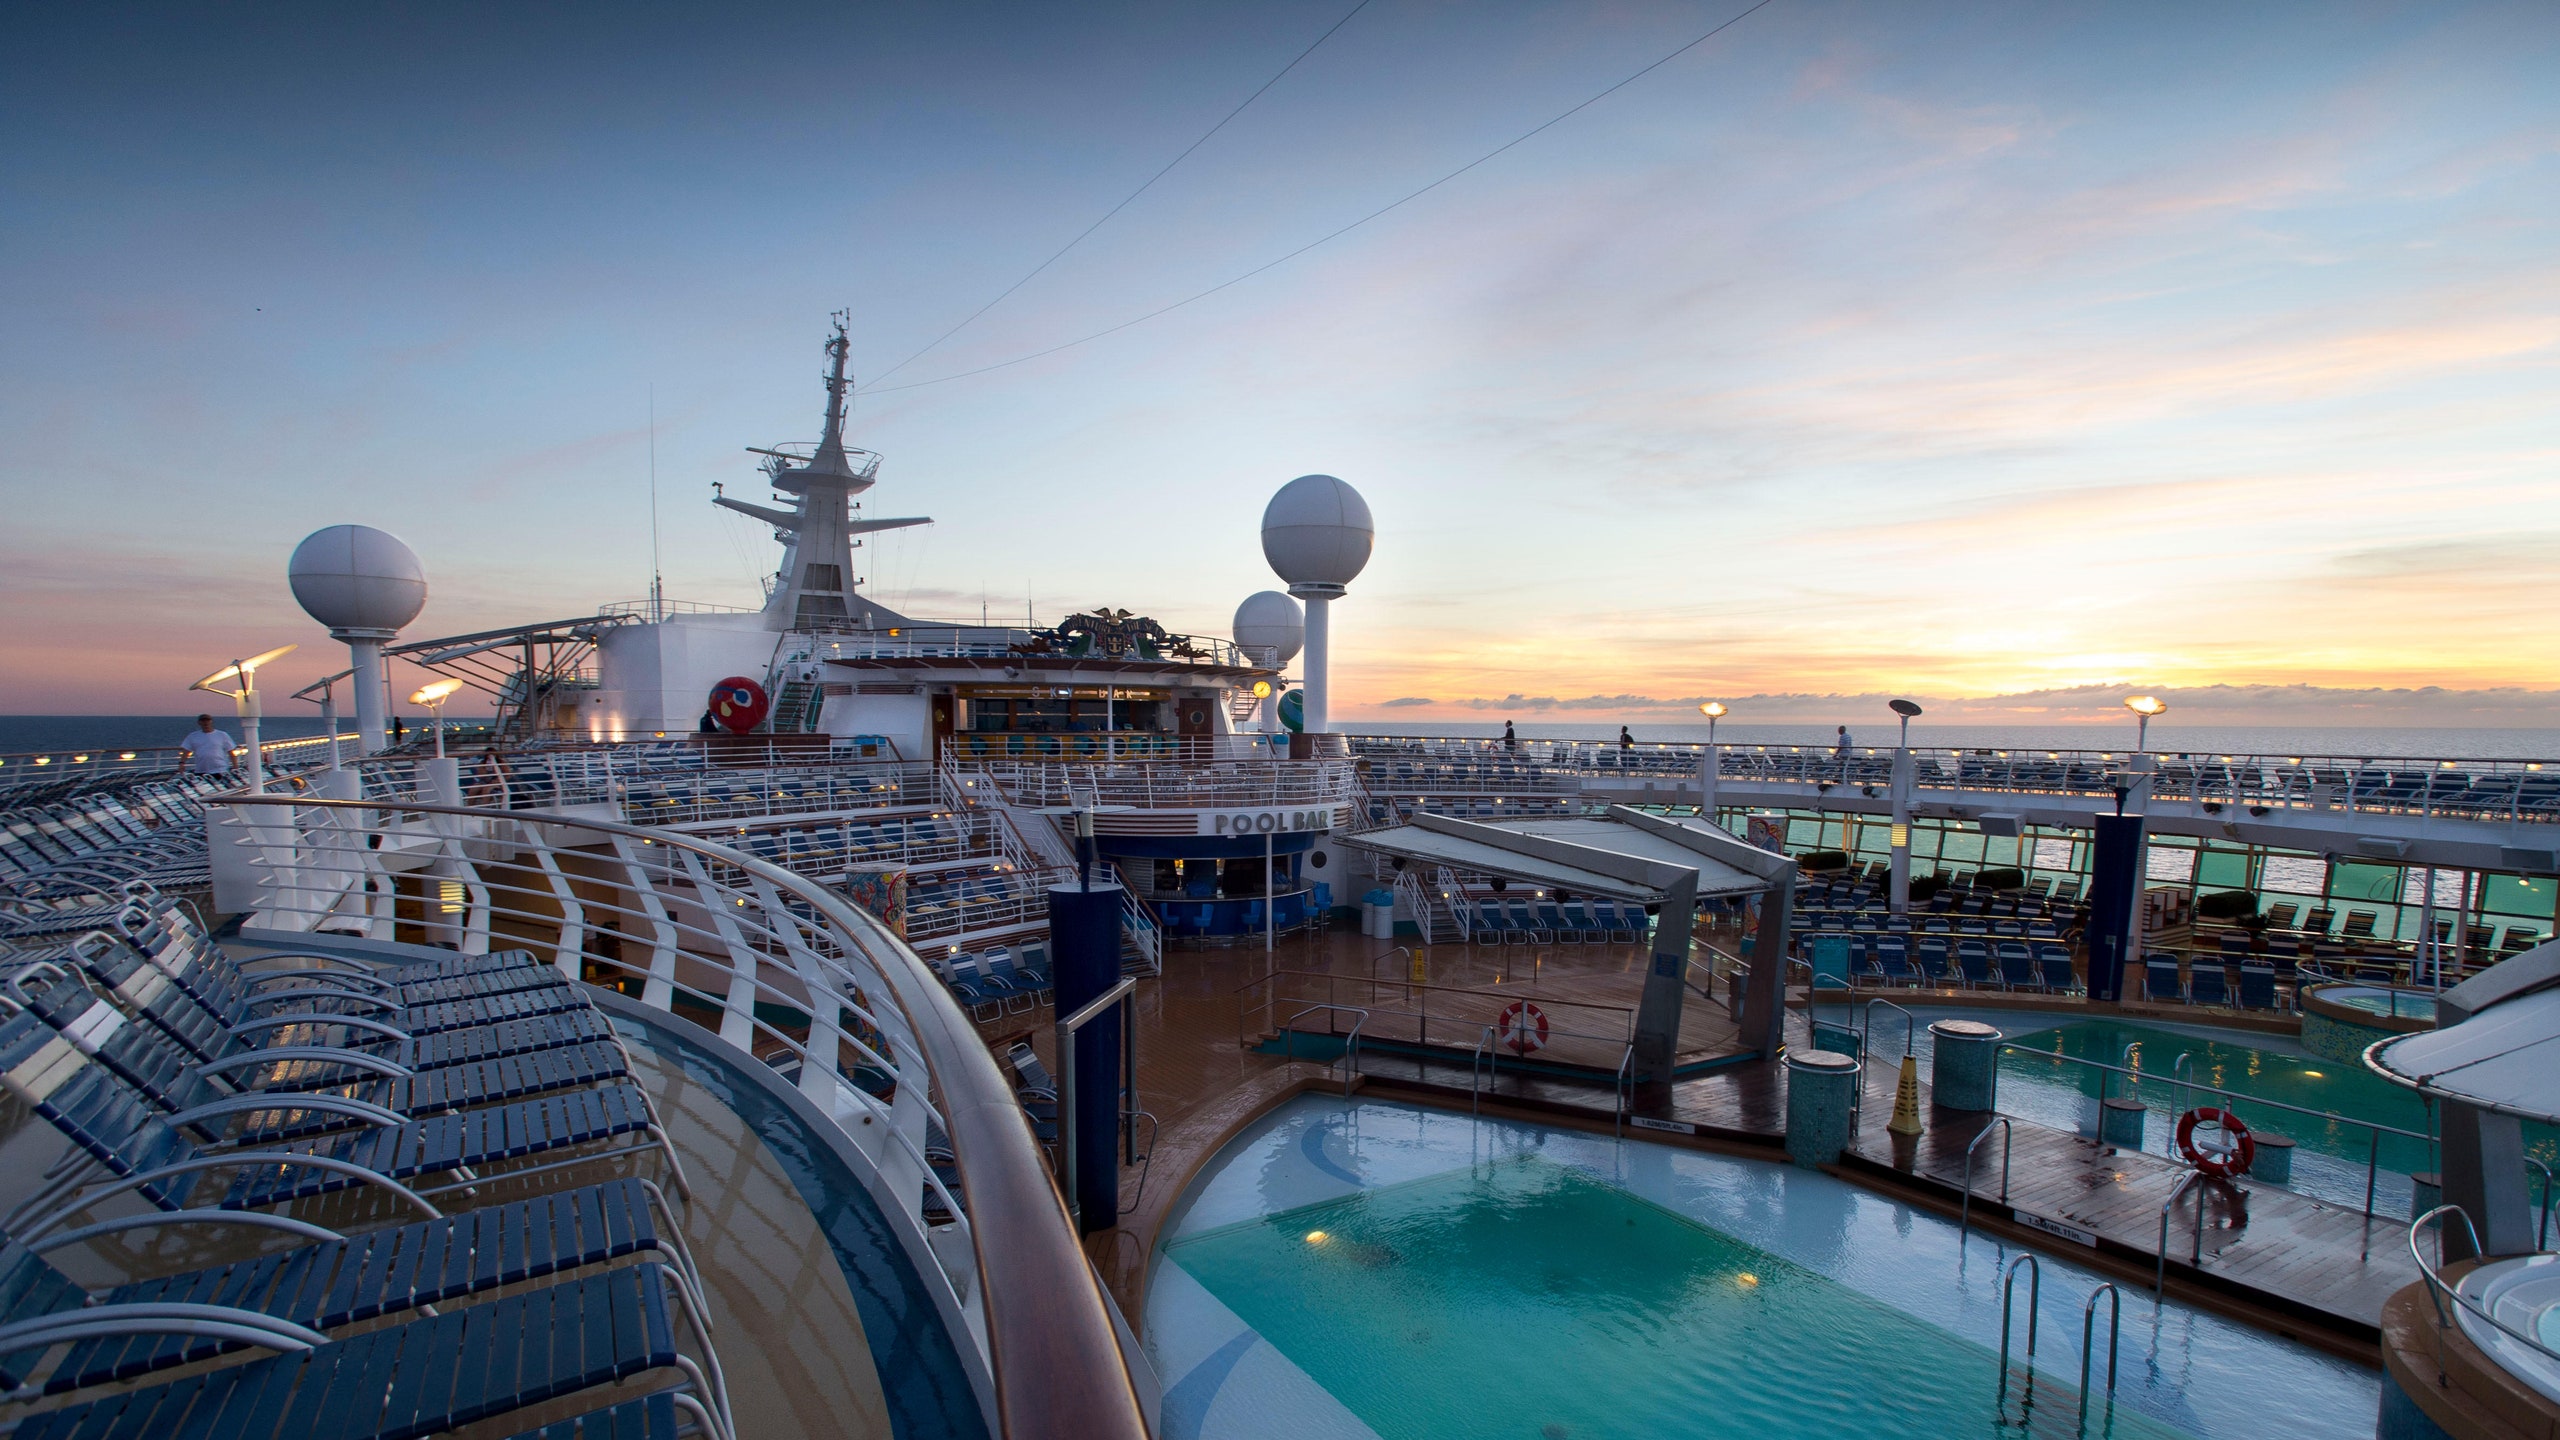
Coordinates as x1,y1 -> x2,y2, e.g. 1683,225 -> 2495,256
0,904 -> 735,1440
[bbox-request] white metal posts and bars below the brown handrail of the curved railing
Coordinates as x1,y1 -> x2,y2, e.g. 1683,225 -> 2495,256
215,797 -> 1075,1383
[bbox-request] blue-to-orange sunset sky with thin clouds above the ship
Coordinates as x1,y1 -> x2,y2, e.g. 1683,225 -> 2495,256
0,0 -> 2560,725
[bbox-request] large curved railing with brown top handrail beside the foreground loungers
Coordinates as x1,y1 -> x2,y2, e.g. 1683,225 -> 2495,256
215,797 -> 1144,1440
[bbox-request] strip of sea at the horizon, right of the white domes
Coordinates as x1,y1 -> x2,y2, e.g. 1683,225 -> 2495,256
1341,717 -> 2560,761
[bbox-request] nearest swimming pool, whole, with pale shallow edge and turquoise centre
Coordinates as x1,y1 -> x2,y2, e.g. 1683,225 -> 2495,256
1144,1097 -> 2378,1440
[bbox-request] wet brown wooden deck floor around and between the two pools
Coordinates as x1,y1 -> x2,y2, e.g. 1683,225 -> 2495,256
986,917 -> 2417,1353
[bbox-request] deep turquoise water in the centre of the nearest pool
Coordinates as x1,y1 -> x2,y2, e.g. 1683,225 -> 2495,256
1167,1156 -> 2176,1440
